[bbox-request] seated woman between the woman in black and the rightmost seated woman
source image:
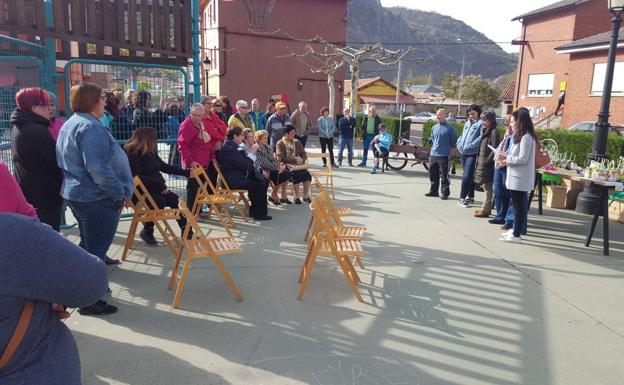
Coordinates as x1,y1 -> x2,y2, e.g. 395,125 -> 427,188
255,130 -> 291,206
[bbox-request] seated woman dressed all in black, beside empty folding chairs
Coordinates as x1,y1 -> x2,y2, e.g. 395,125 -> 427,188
217,127 -> 271,221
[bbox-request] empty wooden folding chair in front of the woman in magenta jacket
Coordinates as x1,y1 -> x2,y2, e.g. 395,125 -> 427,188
191,167 -> 236,236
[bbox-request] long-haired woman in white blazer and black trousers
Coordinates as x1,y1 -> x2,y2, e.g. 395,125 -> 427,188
498,107 -> 537,243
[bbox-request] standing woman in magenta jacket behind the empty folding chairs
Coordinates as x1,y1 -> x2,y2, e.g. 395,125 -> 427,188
178,103 -> 216,214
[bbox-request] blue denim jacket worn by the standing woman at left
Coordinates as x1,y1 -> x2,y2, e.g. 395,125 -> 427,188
56,113 -> 134,202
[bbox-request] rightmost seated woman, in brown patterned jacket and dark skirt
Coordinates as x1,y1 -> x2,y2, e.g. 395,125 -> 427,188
275,124 -> 312,205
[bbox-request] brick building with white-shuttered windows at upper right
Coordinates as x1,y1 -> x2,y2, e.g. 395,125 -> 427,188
513,0 -> 624,127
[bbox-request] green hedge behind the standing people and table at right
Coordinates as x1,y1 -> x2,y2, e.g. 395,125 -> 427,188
423,122 -> 624,165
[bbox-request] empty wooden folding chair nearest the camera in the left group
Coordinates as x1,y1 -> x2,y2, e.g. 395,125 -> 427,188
167,200 -> 243,308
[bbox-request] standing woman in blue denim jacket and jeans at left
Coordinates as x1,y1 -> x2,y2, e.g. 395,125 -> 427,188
56,83 -> 134,315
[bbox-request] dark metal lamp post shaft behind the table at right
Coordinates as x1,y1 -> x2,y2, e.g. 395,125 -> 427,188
588,13 -> 622,160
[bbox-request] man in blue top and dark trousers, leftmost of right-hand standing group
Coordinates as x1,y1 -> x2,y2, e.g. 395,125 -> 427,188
425,108 -> 457,199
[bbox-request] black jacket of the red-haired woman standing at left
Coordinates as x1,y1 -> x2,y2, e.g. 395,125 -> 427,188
11,110 -> 63,208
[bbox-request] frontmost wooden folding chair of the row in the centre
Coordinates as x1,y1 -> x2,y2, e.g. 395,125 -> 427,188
297,201 -> 366,302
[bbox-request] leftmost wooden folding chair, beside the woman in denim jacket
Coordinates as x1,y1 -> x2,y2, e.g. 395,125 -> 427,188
121,175 -> 183,261
